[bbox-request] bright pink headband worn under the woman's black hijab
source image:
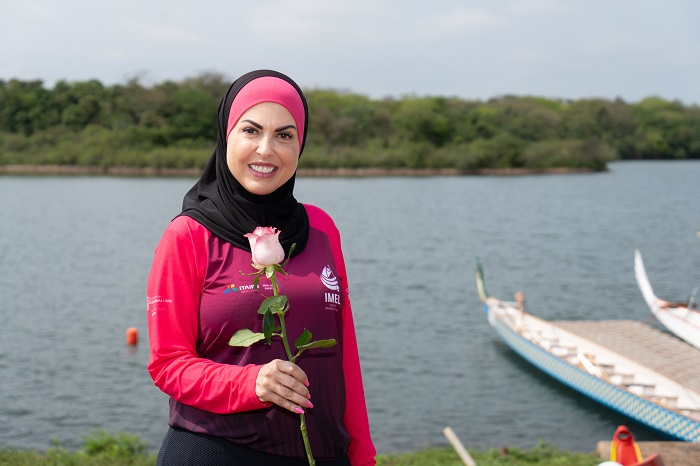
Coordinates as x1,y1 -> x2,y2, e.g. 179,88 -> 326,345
226,76 -> 305,142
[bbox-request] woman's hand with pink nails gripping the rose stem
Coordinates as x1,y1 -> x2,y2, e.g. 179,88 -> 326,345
255,359 -> 314,414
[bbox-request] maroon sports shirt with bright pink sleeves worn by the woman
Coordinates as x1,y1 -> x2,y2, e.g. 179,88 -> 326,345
147,205 -> 376,465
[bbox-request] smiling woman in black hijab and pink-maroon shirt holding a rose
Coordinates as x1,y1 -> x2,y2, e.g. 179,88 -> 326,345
147,70 -> 375,466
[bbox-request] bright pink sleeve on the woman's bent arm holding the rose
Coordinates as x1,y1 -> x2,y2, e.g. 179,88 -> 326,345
147,217 -> 269,414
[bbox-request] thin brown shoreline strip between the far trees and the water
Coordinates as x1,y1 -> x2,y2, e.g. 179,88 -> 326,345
0,165 -> 593,178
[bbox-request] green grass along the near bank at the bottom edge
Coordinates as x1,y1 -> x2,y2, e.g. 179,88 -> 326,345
0,430 -> 603,466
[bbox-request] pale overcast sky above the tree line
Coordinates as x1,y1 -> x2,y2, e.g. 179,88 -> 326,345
0,0 -> 700,105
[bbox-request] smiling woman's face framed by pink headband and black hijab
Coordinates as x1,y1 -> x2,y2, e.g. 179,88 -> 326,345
226,102 -> 301,195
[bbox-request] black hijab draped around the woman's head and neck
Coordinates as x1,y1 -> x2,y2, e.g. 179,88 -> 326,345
180,70 -> 309,255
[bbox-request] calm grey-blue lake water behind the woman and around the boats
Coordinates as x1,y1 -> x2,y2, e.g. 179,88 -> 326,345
0,162 -> 700,453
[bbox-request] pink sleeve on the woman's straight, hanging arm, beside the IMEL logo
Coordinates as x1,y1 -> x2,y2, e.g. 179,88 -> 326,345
307,206 -> 377,466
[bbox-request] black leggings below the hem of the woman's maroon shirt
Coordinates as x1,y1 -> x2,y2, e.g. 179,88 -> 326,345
156,427 -> 350,466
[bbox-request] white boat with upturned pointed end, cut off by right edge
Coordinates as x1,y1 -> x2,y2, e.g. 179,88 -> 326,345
634,250 -> 700,349
